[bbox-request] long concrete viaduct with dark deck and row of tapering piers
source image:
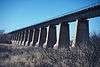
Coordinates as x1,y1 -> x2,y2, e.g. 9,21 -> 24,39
8,4 -> 100,48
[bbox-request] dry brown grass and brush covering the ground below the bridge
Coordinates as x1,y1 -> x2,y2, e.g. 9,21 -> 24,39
0,34 -> 100,67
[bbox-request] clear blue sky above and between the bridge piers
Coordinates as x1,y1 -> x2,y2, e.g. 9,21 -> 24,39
0,0 -> 100,38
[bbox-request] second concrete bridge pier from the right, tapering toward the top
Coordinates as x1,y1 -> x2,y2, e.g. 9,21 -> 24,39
58,22 -> 70,48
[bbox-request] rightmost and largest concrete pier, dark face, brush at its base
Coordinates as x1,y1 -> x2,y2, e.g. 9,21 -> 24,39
76,19 -> 89,46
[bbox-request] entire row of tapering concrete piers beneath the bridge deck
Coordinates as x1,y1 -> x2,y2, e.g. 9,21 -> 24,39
11,19 -> 89,48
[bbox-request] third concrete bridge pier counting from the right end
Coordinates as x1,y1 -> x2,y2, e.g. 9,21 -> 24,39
46,25 -> 57,48
